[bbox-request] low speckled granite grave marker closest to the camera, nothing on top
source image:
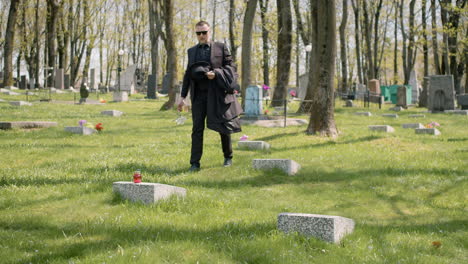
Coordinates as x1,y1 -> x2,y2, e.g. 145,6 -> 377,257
278,213 -> 355,243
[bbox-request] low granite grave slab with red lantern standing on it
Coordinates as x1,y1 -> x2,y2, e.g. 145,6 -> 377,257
112,181 -> 187,204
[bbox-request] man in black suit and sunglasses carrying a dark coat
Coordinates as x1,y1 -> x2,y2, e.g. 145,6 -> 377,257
177,21 -> 242,171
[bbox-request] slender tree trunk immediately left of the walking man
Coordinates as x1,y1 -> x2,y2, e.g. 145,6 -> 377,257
158,0 -> 177,110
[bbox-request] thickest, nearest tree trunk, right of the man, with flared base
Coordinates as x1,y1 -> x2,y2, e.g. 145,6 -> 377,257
306,0 -> 338,137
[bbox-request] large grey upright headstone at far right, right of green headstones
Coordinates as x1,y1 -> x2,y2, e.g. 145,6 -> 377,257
427,75 -> 455,112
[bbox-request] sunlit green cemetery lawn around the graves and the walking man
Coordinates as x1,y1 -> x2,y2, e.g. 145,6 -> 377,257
0,95 -> 468,264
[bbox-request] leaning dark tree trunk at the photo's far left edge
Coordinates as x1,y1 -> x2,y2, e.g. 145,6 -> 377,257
3,0 -> 20,87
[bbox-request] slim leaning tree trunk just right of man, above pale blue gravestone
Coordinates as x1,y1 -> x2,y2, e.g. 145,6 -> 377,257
241,0 -> 257,106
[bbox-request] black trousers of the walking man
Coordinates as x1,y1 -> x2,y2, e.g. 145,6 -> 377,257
190,92 -> 232,165
